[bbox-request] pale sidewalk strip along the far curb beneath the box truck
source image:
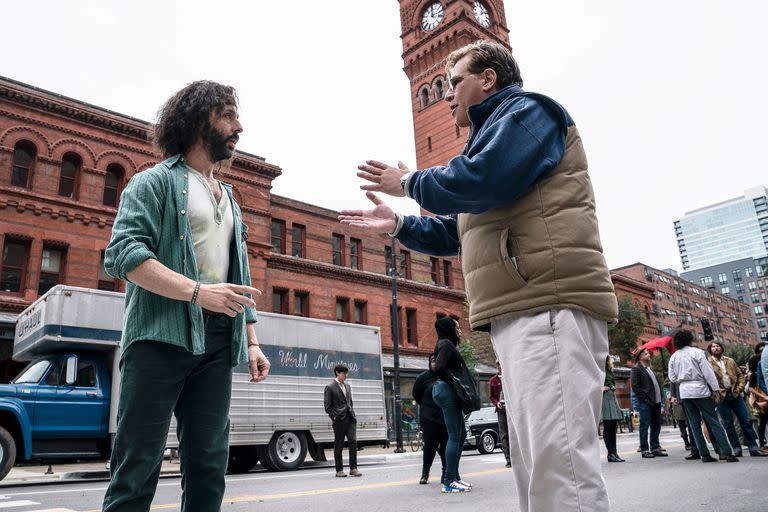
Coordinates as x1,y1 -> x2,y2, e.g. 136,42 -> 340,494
0,444 -> 421,488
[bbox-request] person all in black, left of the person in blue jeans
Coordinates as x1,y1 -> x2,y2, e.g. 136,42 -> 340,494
413,353 -> 448,485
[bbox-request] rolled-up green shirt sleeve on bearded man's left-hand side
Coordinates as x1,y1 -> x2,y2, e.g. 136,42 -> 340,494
104,172 -> 165,279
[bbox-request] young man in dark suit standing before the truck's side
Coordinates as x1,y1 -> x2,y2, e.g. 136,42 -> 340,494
323,364 -> 363,478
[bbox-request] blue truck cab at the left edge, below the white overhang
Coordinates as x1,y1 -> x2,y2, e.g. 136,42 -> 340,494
0,352 -> 111,478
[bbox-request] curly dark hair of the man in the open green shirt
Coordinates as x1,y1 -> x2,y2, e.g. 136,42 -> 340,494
152,80 -> 238,158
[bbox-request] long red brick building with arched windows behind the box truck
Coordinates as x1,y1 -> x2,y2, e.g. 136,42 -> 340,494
0,78 -> 469,379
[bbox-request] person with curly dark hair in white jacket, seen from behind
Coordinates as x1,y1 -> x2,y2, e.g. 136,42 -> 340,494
669,329 -> 739,462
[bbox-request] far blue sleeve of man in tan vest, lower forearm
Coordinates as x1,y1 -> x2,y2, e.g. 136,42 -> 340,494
395,215 -> 459,256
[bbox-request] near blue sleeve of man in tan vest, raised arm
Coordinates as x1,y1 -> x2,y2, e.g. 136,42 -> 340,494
408,97 -> 568,215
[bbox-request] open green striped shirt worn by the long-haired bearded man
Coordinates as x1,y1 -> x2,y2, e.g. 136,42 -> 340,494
104,155 -> 256,366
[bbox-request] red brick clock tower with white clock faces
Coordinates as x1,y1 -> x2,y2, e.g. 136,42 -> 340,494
399,0 -> 509,169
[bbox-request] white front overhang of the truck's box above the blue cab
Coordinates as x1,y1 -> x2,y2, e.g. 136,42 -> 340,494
13,285 -> 125,361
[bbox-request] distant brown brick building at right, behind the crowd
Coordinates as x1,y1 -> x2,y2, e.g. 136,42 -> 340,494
611,263 -> 758,344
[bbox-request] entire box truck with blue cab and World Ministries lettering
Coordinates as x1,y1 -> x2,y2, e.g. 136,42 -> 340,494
0,285 -> 387,479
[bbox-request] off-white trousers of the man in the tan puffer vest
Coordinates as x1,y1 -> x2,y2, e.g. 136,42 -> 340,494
491,309 -> 610,512
